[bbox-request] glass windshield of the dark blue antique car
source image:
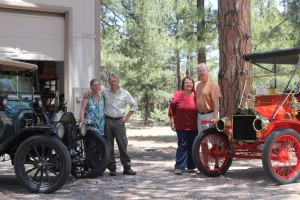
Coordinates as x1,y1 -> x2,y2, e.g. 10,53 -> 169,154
0,74 -> 33,95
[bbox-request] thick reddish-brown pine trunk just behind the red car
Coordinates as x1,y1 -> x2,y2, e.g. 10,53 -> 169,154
218,0 -> 252,117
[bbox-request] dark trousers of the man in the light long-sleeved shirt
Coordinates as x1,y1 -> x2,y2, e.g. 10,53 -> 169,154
104,118 -> 131,171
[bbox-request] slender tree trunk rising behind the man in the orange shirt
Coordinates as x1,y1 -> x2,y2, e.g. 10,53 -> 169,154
197,0 -> 206,68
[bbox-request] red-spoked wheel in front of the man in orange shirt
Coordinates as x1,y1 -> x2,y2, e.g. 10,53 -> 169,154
192,128 -> 232,177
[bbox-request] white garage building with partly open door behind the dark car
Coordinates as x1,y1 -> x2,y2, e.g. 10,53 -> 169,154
0,0 -> 100,118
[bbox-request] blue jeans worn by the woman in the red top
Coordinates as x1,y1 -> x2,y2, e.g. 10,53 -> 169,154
175,130 -> 198,170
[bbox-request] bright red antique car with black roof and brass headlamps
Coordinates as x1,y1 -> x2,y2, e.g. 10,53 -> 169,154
193,47 -> 300,184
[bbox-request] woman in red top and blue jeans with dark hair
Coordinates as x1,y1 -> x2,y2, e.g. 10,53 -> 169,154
169,76 -> 198,175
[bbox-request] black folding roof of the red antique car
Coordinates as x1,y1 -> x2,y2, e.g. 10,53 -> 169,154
243,46 -> 300,65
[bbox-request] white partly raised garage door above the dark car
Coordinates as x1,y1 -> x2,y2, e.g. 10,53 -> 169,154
0,8 -> 64,61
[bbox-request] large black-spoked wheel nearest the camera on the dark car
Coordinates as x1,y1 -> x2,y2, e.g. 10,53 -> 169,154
14,135 -> 71,193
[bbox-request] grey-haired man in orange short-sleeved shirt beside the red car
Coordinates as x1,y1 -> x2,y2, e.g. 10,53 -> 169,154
195,63 -> 221,133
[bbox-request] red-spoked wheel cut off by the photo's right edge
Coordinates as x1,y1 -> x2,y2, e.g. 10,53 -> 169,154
262,129 -> 300,184
